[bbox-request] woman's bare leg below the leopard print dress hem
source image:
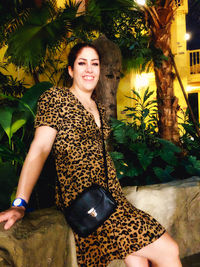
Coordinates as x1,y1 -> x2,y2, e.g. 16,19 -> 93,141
125,233 -> 182,267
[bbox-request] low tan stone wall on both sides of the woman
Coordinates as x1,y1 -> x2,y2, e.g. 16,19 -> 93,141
0,177 -> 200,267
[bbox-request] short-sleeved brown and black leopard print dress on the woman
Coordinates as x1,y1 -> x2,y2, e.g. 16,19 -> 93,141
35,87 -> 165,267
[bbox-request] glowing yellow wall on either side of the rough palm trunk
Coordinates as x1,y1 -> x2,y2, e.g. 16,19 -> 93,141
117,0 -> 200,124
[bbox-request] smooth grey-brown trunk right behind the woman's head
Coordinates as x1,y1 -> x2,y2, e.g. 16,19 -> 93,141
93,35 -> 122,119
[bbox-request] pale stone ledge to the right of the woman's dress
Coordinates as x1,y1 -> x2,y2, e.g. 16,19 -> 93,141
123,177 -> 200,257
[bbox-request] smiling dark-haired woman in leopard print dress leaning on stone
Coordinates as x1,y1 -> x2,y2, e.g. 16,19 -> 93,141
0,44 -> 181,267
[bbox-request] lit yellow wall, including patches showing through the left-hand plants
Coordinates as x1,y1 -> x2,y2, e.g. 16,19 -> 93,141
0,0 -> 200,123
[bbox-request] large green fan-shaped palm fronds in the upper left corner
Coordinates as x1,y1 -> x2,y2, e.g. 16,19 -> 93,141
0,0 -> 80,83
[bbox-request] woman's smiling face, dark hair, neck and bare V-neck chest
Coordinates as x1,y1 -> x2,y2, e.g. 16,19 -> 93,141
68,44 -> 100,127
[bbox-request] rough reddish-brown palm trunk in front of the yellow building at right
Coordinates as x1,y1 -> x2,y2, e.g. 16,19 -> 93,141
145,3 -> 180,145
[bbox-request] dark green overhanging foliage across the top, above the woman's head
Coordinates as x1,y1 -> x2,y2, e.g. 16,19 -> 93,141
0,0 -> 164,80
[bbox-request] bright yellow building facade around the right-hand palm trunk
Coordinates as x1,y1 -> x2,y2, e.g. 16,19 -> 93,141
117,0 -> 200,125
